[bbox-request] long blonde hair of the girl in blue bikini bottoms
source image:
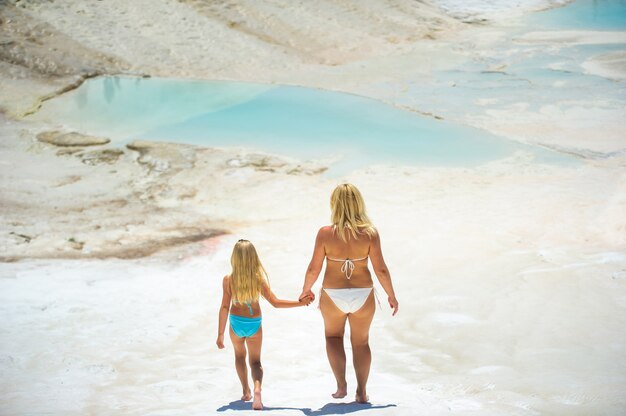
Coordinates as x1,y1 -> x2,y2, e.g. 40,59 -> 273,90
230,240 -> 267,303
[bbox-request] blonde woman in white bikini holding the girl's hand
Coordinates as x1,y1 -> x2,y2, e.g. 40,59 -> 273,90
300,184 -> 398,403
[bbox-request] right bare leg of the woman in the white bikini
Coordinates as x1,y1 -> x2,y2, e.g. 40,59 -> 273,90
348,290 -> 376,403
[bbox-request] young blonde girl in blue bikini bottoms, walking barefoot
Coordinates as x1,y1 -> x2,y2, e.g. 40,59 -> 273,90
216,240 -> 312,410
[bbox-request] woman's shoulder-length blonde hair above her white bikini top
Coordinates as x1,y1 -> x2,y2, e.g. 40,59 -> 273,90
330,183 -> 376,241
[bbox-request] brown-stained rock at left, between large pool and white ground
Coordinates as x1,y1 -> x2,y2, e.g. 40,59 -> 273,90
0,117 -> 324,262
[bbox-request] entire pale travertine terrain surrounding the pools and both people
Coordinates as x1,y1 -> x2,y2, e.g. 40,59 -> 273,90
0,0 -> 626,416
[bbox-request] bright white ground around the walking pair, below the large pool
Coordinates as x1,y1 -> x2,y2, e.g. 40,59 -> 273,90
0,158 -> 626,415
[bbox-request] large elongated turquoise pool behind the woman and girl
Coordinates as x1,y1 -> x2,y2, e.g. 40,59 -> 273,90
30,77 -> 574,173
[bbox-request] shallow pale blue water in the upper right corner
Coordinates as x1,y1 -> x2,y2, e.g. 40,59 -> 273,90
394,0 -> 626,148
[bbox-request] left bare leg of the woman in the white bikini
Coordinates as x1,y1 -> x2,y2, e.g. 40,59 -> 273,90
320,290 -> 348,399
